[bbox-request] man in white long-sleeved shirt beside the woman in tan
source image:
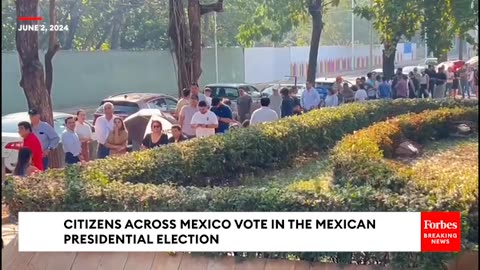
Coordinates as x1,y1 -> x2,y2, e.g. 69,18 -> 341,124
95,102 -> 114,159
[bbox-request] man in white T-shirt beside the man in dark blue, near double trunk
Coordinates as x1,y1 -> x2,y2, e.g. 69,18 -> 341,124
190,101 -> 218,138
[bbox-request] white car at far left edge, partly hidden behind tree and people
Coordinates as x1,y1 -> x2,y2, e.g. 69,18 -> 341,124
2,112 -> 94,172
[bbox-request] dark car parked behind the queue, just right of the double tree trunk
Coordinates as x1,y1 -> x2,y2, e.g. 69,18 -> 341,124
205,83 -> 261,114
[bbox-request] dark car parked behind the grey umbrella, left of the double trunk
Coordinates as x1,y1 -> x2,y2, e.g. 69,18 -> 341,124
93,92 -> 178,124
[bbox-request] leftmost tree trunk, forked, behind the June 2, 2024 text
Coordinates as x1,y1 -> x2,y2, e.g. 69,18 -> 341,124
15,0 -> 60,167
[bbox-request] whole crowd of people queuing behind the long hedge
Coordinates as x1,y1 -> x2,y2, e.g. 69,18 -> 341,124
13,62 -> 478,176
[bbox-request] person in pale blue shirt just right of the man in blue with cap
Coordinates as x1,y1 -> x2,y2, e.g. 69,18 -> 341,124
62,116 -> 84,165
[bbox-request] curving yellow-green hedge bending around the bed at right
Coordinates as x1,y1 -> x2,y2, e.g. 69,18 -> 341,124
331,108 -> 478,241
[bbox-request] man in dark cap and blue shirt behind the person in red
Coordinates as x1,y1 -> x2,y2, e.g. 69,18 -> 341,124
28,109 -> 60,170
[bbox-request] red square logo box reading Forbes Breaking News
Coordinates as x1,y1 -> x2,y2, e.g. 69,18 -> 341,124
420,212 -> 461,252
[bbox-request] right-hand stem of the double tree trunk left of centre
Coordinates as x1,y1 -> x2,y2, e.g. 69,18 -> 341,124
188,0 -> 202,82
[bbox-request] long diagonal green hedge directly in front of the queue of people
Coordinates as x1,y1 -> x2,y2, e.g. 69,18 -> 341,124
21,100 -> 478,186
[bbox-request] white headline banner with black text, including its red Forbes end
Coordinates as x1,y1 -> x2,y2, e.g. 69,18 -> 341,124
19,212 -> 460,252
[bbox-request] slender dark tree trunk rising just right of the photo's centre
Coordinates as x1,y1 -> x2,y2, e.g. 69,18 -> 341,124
307,0 -> 323,83
